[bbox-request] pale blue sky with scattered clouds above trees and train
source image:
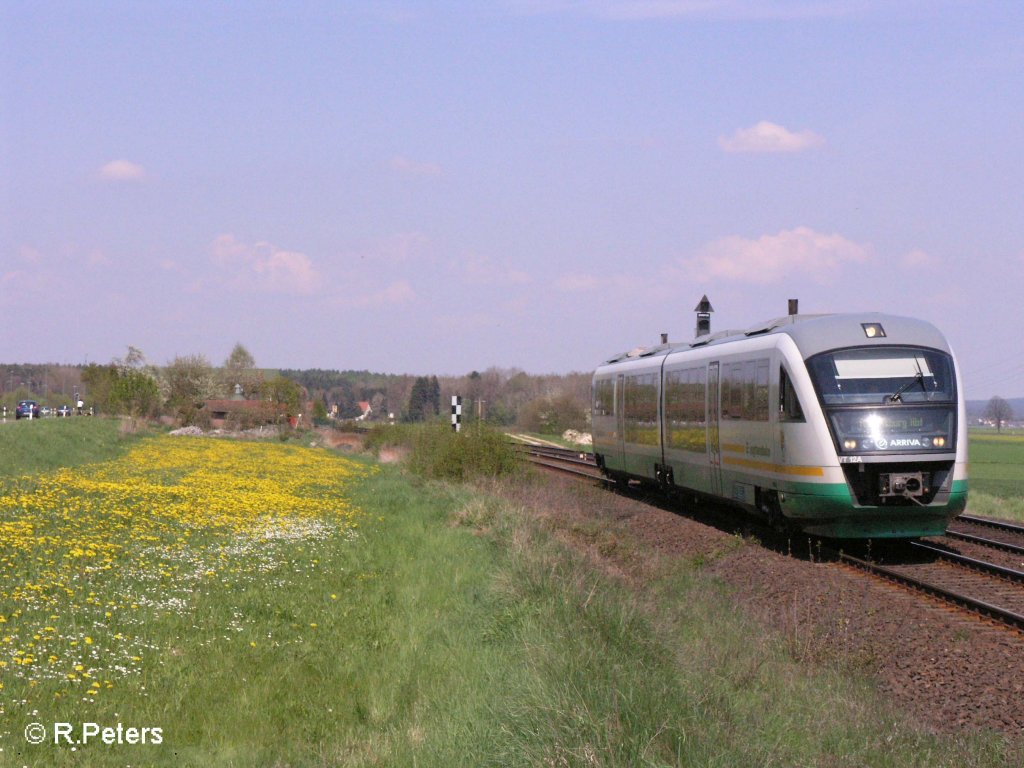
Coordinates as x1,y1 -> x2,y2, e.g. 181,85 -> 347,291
0,0 -> 1024,398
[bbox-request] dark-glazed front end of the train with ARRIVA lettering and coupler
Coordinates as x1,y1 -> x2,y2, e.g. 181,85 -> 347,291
807,344 -> 967,537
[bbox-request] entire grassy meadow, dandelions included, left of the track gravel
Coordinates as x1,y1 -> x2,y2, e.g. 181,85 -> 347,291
0,423 -> 1010,768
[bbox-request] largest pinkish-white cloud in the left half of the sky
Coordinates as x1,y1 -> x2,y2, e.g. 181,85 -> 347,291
210,234 -> 317,294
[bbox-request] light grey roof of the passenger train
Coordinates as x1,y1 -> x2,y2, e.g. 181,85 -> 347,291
603,312 -> 949,366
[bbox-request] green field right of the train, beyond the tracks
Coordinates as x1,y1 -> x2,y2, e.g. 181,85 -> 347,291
968,432 -> 1024,522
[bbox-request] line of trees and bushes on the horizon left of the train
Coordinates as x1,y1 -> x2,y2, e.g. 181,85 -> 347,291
0,343 -> 590,433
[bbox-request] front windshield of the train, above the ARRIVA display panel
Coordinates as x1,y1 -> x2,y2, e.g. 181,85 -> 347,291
807,347 -> 956,406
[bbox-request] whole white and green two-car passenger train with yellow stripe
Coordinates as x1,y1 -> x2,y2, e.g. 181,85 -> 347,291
592,309 -> 968,539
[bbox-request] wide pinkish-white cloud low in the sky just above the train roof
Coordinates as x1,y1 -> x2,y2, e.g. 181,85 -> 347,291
681,226 -> 872,284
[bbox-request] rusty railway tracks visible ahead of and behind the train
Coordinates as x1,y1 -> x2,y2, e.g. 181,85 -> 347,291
516,444 -> 1024,632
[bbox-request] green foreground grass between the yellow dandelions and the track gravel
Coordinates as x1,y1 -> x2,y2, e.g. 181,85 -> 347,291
0,423 -> 1021,768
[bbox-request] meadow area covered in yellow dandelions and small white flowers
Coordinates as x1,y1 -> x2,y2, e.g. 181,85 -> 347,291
0,436 -> 372,714
